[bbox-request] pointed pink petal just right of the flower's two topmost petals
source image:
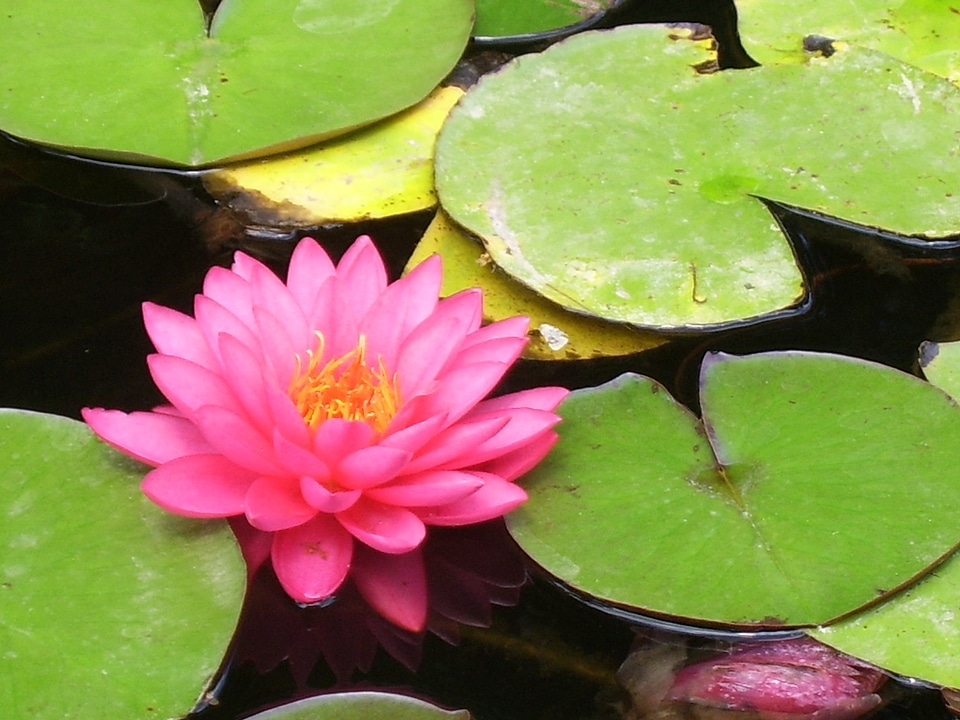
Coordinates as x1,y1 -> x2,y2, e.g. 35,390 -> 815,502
360,255 -> 441,368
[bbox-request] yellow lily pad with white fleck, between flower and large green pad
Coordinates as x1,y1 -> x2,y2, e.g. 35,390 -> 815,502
406,211 -> 666,360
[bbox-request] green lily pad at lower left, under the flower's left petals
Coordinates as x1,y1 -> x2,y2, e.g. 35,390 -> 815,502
0,410 -> 246,720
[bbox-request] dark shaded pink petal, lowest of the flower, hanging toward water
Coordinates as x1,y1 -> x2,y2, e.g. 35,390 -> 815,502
353,545 -> 427,632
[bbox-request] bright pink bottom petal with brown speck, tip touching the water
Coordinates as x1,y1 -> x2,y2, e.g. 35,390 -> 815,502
270,514 -> 353,603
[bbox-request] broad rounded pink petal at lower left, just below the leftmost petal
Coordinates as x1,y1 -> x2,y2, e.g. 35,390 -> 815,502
141,455 -> 256,517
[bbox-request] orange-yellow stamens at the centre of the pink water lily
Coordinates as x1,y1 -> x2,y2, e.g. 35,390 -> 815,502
287,332 -> 400,433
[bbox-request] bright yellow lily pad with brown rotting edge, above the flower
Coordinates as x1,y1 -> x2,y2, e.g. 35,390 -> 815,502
203,87 -> 463,228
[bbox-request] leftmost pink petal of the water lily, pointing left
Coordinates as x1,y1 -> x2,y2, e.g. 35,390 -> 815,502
81,408 -> 213,466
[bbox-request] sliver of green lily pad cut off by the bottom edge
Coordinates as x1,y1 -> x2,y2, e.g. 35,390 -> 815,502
250,692 -> 470,720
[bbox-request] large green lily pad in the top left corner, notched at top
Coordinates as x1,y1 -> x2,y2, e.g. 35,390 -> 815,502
0,0 -> 473,166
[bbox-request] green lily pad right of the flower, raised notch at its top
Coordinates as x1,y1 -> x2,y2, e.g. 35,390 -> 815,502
508,352 -> 960,628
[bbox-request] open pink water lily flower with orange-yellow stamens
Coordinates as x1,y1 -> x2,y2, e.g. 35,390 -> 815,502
83,237 -> 567,626
